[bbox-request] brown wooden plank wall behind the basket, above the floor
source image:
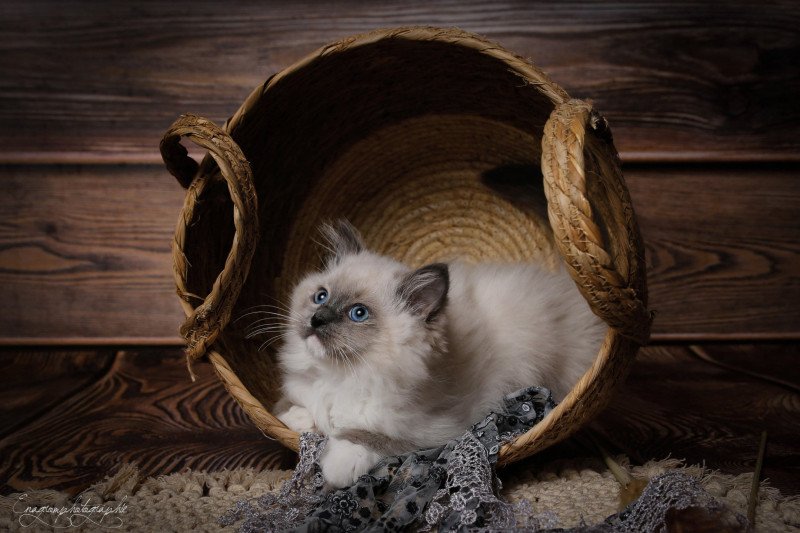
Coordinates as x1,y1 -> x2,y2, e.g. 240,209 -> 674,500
0,0 -> 800,345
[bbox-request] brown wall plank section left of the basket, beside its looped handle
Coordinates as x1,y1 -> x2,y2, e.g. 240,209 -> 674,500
0,166 -> 183,342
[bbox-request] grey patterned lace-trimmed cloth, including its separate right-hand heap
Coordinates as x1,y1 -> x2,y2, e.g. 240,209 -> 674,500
219,387 -> 747,533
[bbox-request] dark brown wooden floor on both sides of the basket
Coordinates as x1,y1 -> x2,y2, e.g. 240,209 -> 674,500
0,344 -> 800,494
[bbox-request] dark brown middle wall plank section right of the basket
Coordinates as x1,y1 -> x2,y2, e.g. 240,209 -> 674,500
625,160 -> 800,340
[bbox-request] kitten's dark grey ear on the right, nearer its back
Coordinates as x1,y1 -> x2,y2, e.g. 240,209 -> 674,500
397,263 -> 450,322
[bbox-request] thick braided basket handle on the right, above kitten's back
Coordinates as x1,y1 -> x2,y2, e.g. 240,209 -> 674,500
542,100 -> 652,345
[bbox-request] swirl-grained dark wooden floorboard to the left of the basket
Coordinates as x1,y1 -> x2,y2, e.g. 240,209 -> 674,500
0,348 -> 293,494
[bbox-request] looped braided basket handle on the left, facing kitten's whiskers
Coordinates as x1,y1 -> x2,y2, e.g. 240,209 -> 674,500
160,114 -> 259,380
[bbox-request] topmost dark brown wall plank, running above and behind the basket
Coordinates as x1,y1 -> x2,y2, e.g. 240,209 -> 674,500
0,0 -> 800,162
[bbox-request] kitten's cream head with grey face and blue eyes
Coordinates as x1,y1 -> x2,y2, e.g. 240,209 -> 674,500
286,220 -> 449,369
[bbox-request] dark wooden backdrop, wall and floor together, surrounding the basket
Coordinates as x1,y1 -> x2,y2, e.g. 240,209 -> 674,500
0,0 -> 800,493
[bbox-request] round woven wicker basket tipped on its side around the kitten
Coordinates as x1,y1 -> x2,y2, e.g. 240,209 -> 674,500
161,27 -> 651,463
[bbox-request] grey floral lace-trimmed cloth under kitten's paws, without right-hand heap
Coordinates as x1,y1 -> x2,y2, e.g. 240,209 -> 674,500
219,387 -> 555,533
